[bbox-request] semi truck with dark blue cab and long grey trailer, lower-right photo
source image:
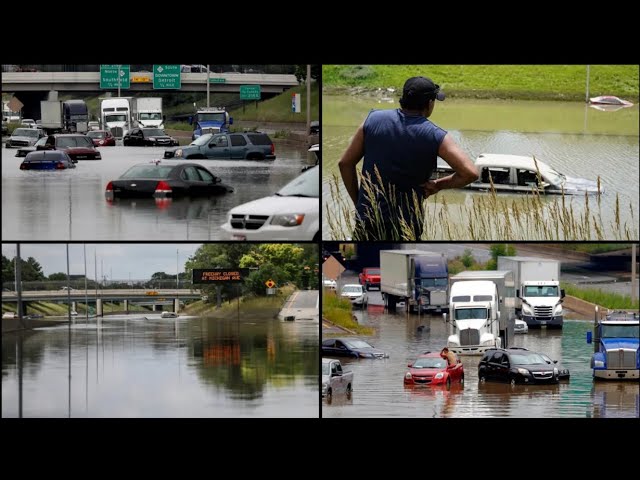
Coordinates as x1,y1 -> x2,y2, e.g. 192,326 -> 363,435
380,250 -> 449,312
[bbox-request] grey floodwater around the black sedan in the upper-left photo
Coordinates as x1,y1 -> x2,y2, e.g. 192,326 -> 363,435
2,144 -> 316,241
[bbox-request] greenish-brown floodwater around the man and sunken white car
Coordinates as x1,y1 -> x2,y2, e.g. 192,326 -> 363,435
322,95 -> 640,240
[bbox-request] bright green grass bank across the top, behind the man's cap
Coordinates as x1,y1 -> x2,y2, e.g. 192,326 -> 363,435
322,65 -> 639,102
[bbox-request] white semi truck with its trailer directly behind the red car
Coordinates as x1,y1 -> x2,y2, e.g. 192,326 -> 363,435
445,270 -> 516,355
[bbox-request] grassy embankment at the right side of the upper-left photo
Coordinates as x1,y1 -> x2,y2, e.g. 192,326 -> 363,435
230,82 -> 320,123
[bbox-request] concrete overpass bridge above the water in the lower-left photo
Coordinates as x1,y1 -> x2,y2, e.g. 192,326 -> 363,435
2,289 -> 202,316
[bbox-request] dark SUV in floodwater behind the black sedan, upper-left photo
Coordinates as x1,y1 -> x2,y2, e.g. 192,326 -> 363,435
164,132 -> 276,160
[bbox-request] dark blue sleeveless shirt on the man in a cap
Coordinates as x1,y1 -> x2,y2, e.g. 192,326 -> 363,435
356,109 -> 447,222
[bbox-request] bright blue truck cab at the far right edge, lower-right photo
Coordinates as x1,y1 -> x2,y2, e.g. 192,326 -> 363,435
587,312 -> 640,380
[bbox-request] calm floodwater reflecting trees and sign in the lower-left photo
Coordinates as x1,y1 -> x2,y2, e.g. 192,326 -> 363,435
2,314 -> 319,418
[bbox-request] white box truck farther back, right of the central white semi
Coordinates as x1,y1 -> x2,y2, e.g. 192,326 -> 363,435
498,257 -> 565,328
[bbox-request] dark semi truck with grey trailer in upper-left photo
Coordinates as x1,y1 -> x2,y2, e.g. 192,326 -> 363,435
40,100 -> 89,135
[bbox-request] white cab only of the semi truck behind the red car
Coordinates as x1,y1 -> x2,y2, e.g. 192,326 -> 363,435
447,280 -> 501,355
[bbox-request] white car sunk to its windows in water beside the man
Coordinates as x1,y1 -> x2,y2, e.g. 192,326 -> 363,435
431,153 -> 604,195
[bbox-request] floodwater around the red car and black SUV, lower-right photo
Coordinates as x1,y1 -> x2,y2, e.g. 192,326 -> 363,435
322,284 -> 640,418
